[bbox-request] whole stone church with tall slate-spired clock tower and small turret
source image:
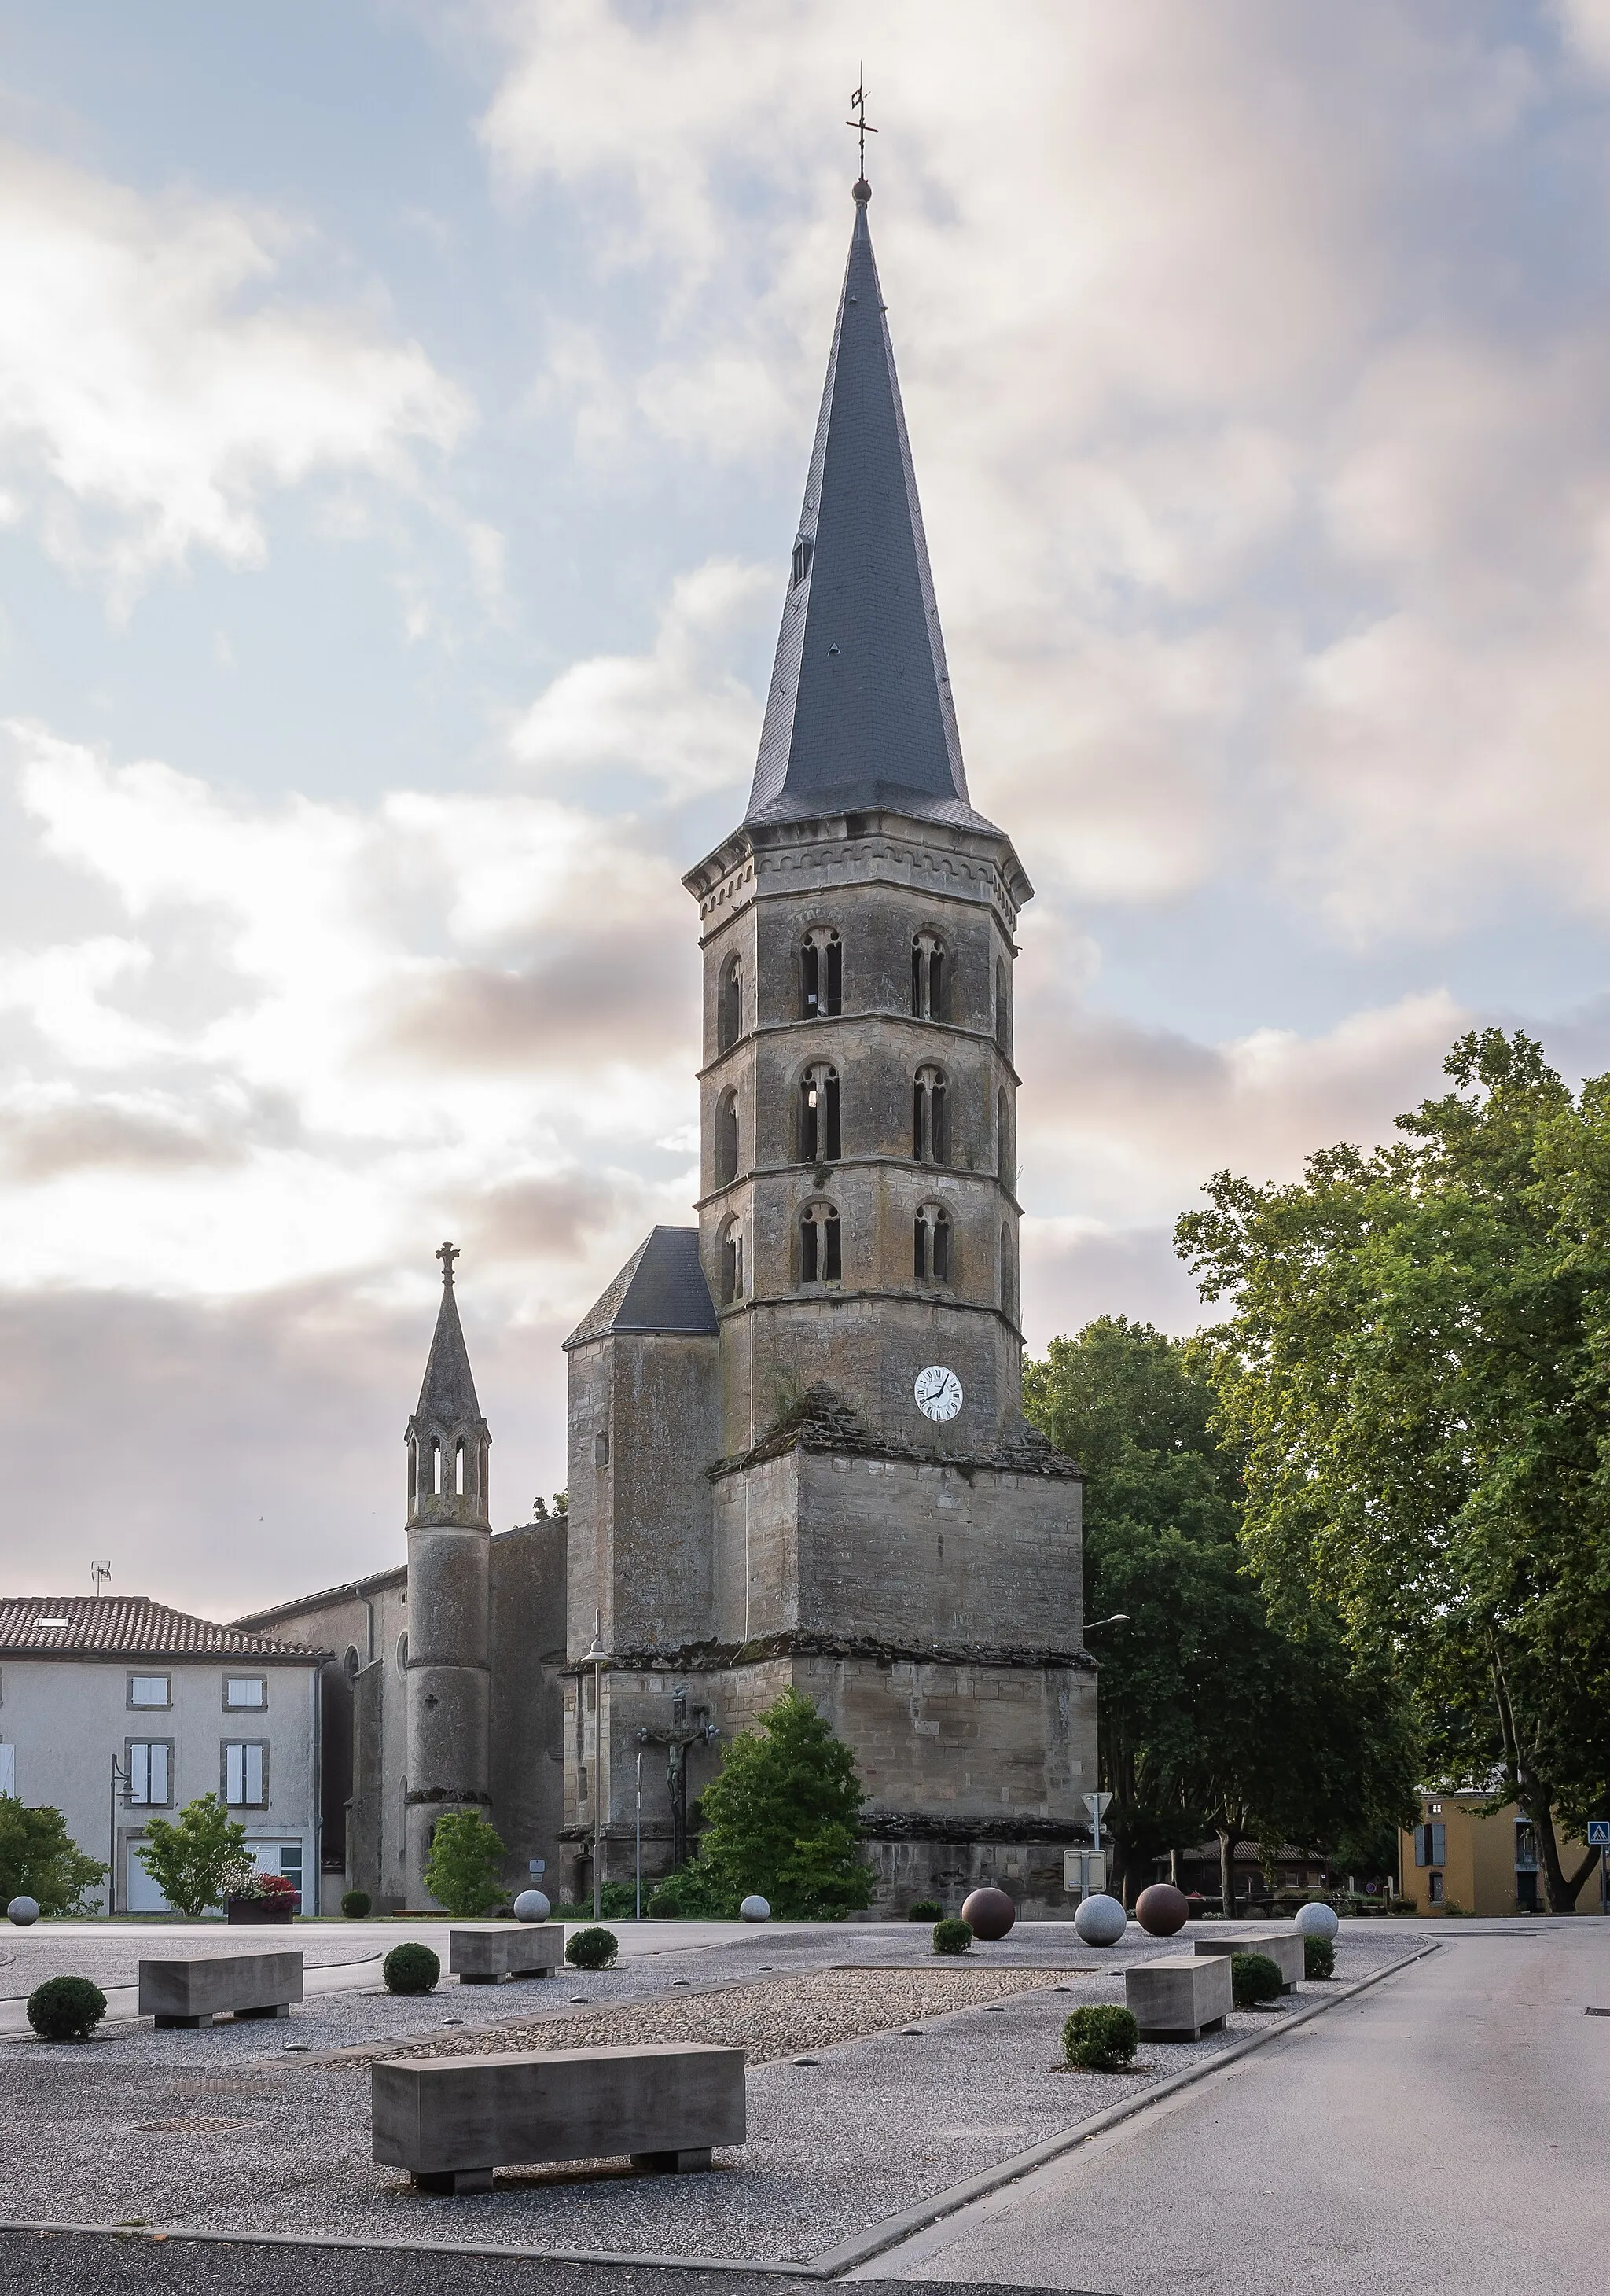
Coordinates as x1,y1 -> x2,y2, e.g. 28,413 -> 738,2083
241,179 -> 1097,1915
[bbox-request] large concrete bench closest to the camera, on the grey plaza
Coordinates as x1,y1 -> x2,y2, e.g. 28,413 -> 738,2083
372,2041 -> 747,2193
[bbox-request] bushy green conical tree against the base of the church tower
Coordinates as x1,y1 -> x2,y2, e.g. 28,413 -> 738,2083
678,1690 -> 873,1922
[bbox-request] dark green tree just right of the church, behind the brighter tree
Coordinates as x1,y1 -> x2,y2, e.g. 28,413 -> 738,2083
1024,1315 -> 1417,1906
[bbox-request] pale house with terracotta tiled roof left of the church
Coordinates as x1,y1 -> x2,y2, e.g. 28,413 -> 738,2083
0,1595 -> 324,1912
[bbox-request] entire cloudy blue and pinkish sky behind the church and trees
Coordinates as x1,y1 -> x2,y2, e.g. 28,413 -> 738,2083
0,0 -> 1610,1614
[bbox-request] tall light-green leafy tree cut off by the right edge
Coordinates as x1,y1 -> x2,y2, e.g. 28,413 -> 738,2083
1178,1028 -> 1610,1912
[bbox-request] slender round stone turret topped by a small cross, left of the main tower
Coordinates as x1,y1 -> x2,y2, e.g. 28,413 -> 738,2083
402,1245 -> 491,1906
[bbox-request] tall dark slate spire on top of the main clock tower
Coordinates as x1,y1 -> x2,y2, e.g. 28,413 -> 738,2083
747,182 -> 979,822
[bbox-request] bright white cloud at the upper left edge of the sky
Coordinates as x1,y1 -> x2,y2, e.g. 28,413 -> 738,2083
0,145 -> 469,602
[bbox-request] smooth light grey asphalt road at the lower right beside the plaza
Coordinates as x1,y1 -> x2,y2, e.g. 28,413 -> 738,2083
866,1917 -> 1610,2296
